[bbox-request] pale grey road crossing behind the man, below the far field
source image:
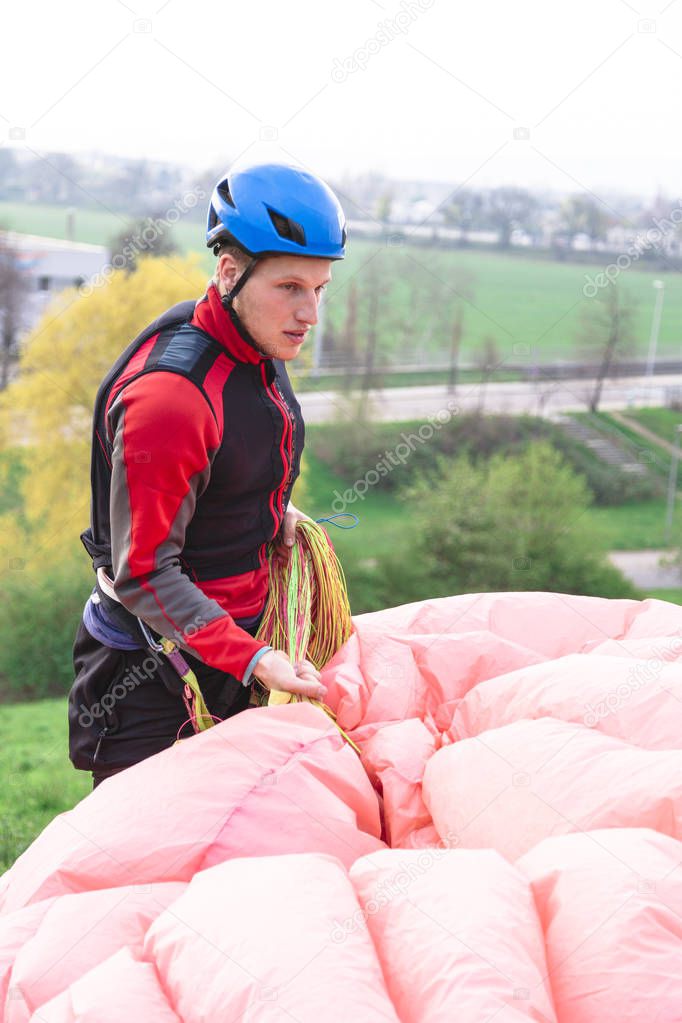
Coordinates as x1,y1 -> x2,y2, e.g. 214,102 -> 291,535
298,373 -> 682,422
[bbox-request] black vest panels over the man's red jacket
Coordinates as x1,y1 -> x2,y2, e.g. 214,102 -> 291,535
81,302 -> 305,581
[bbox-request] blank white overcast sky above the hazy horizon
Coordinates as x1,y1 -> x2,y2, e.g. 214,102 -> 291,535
0,0 -> 682,197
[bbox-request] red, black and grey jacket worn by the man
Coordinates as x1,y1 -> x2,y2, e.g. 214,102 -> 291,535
82,284 -> 304,682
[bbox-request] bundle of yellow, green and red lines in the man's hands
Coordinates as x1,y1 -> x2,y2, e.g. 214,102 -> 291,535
256,520 -> 359,752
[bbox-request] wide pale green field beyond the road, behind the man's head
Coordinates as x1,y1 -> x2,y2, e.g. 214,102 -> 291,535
0,202 -> 682,369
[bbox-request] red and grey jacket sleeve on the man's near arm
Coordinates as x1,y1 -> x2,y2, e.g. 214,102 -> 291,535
108,371 -> 267,682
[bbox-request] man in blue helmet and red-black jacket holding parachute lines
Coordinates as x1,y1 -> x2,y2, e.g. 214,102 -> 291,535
69,164 -> 346,785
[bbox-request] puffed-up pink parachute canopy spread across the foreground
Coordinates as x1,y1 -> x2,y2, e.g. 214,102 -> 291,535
0,593 -> 682,1023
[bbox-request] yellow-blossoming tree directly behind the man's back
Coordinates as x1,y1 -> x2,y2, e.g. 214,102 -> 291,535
0,258 -> 206,565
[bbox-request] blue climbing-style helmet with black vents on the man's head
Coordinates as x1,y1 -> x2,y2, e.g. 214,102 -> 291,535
206,164 -> 346,259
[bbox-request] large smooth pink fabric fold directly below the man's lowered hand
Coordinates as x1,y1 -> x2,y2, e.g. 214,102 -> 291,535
0,704 -> 382,913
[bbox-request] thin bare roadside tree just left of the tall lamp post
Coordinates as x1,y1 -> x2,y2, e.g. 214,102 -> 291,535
577,283 -> 635,412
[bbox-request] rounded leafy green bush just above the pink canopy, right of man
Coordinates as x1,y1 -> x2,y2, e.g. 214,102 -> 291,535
368,441 -> 640,604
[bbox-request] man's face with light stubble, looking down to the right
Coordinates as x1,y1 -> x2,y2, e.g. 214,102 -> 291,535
221,256 -> 331,361
